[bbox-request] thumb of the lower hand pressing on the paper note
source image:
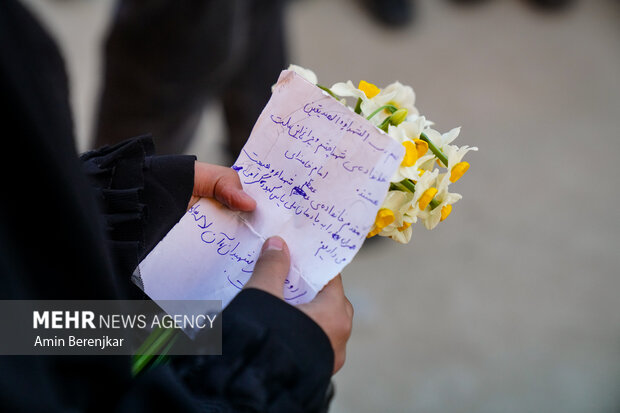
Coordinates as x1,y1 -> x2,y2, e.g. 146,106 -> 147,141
244,237 -> 291,299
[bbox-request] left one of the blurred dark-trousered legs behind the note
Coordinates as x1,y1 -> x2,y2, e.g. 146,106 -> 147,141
94,0 -> 244,153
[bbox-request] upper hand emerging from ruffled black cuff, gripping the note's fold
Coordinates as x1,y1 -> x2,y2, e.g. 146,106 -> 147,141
188,162 -> 256,212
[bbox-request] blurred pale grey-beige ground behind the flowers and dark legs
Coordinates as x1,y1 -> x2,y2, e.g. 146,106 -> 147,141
21,0 -> 620,413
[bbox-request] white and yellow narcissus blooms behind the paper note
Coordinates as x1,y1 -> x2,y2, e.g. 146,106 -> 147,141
289,65 -> 478,243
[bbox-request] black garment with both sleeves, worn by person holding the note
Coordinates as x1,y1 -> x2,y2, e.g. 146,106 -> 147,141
0,0 -> 333,412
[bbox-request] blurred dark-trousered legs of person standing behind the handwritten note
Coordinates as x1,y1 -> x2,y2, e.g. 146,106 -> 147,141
93,0 -> 286,161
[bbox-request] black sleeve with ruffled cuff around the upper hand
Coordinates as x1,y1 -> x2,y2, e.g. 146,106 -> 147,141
80,136 -> 196,292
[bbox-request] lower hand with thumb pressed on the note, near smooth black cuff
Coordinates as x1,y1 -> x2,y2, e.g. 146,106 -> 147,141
244,237 -> 353,373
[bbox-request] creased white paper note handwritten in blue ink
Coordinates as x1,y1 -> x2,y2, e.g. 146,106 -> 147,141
134,71 -> 404,306
